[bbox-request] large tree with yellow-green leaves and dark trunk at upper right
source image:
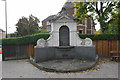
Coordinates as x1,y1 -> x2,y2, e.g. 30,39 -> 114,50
73,1 -> 116,33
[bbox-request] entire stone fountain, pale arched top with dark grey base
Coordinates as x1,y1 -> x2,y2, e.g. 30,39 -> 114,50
31,12 -> 97,72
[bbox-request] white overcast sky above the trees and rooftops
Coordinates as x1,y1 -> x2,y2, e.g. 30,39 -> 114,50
0,0 -> 99,33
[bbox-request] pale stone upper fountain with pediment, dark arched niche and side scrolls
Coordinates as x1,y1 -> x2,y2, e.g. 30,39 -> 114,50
37,11 -> 92,47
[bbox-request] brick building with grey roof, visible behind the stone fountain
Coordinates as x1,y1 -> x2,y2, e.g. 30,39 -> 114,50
42,2 -> 96,34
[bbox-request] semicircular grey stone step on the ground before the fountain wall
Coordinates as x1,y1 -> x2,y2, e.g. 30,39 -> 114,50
30,59 -> 96,73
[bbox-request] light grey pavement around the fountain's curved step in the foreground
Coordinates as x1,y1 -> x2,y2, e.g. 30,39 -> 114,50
2,60 -> 118,78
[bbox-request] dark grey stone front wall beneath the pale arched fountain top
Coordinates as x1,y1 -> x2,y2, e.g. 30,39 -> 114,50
34,46 -> 96,63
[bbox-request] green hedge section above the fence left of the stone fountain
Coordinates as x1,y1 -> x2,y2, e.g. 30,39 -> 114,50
2,33 -> 49,45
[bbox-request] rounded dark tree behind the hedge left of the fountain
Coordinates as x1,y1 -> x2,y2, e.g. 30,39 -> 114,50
16,15 -> 40,36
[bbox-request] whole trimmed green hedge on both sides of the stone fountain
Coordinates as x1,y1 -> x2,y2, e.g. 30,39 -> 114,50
2,33 -> 118,45
